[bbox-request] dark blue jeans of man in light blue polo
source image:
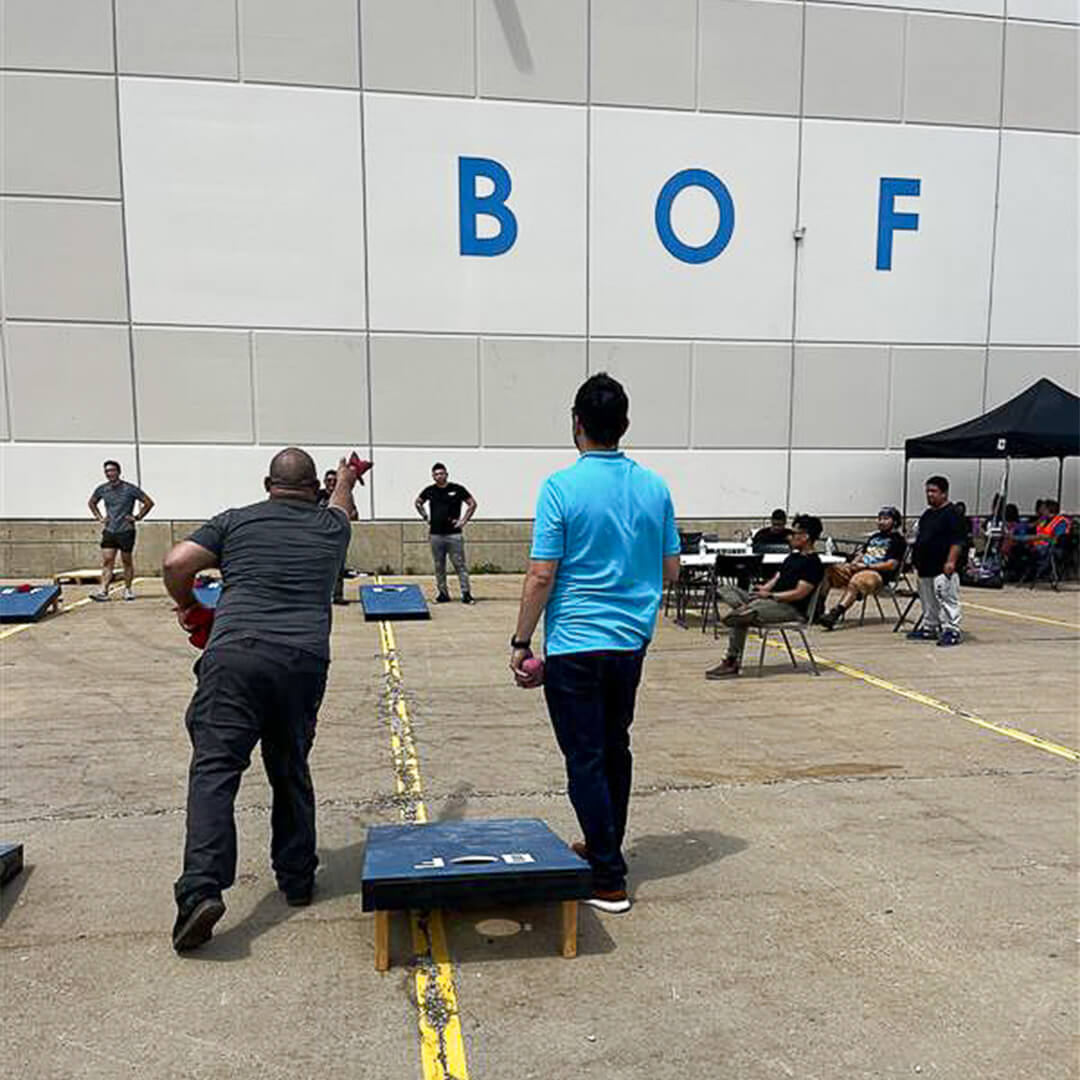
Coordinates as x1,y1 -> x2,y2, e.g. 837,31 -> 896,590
543,648 -> 645,889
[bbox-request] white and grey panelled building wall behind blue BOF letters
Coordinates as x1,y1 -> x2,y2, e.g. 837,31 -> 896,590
0,0 -> 1080,518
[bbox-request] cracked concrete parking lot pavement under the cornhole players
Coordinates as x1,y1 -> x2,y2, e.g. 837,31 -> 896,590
0,576 -> 1080,1080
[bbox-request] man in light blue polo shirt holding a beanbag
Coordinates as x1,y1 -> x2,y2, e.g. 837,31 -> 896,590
510,374 -> 679,914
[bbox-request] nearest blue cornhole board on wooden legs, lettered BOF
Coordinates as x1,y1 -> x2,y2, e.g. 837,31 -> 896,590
361,818 -> 592,971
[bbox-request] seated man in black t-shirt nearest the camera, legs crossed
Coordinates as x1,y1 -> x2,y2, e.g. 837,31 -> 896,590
705,514 -> 825,679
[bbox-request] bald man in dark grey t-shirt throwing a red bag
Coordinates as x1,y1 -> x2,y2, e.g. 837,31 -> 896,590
164,447 -> 356,953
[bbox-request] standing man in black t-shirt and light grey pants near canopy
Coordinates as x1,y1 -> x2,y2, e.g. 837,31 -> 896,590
907,476 -> 967,646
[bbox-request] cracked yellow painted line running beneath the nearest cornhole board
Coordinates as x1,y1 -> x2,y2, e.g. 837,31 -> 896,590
375,577 -> 469,1080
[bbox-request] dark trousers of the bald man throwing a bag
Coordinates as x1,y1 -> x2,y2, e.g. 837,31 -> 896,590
174,638 -> 327,906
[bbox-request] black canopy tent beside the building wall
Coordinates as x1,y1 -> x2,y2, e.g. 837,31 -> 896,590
904,379 -> 1080,519
